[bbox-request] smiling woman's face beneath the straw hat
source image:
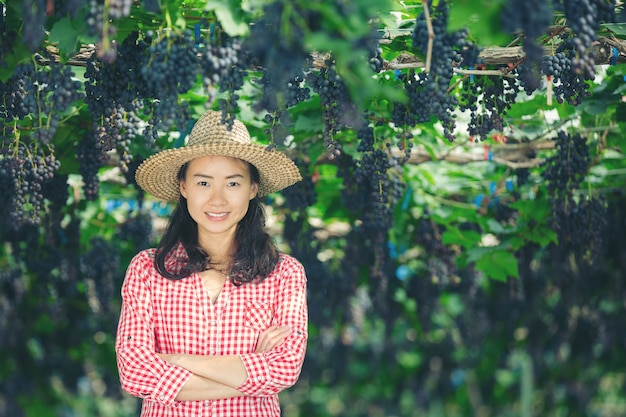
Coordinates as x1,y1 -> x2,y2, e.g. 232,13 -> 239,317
180,156 -> 258,244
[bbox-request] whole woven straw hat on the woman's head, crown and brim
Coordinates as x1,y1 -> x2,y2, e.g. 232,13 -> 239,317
135,110 -> 302,201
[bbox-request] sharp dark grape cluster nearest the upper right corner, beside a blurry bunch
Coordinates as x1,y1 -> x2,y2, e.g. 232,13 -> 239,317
542,37 -> 594,105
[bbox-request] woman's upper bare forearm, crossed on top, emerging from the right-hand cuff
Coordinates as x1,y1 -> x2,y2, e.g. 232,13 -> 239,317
161,354 -> 248,389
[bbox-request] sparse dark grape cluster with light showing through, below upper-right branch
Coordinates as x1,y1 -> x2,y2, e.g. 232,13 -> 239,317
459,76 -> 518,140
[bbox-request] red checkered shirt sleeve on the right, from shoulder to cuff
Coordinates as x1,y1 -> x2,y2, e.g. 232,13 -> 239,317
237,257 -> 308,397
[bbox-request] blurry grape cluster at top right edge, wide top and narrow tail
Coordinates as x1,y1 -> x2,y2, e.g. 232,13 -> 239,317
500,0 -> 553,94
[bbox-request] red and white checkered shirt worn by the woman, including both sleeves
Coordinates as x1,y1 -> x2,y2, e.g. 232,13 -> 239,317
116,249 -> 308,417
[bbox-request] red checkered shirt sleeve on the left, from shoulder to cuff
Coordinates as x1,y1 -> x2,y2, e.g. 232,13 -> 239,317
115,251 -> 191,406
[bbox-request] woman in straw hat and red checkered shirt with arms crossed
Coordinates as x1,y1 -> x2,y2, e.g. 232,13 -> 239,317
116,111 -> 307,417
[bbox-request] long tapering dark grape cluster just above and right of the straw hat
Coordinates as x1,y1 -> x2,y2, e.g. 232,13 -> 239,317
307,60 -> 357,159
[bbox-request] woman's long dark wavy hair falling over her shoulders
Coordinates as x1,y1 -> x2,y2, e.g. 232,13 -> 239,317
154,159 -> 279,285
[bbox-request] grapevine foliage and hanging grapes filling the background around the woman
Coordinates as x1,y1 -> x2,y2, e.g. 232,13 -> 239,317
0,0 -> 626,417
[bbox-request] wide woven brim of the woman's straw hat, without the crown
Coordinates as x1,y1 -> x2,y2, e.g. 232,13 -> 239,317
135,142 -> 302,201
